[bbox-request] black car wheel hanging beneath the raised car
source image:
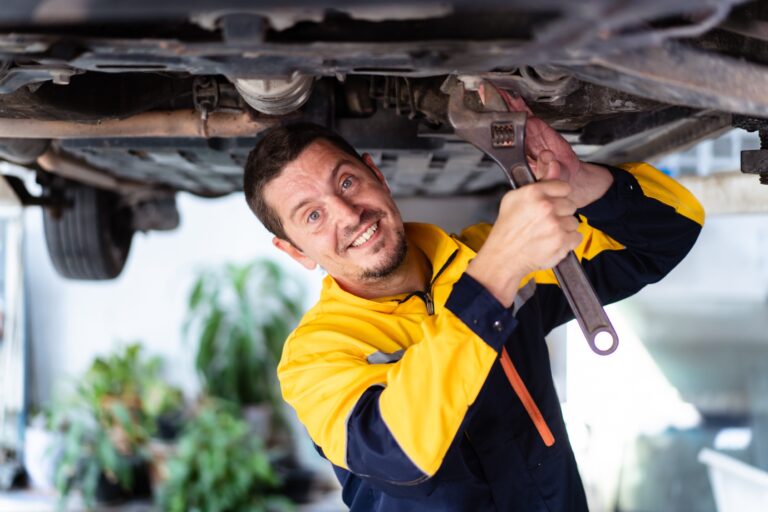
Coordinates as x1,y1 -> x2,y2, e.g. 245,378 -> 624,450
43,182 -> 134,280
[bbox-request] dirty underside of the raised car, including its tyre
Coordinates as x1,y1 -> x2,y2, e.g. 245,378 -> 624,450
0,0 -> 768,279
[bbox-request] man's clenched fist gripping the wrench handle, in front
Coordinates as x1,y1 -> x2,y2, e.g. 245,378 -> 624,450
467,179 -> 581,307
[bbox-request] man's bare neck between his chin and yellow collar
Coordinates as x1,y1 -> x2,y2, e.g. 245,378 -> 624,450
337,245 -> 432,299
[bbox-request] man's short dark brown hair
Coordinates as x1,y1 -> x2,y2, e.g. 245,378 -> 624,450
243,123 -> 363,240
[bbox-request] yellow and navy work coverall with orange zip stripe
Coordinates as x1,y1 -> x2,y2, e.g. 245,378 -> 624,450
278,164 -> 704,512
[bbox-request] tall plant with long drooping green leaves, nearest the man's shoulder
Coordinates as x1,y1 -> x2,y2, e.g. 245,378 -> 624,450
185,259 -> 304,438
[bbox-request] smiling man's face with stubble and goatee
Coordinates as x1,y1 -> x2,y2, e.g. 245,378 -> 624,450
264,139 -> 406,288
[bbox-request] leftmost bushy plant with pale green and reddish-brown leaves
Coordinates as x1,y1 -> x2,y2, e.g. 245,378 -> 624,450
52,343 -> 183,507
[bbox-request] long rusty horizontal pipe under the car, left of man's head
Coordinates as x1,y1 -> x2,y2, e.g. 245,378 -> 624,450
0,109 -> 279,139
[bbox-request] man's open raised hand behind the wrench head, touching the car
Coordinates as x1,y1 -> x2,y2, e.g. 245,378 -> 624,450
500,96 -> 613,208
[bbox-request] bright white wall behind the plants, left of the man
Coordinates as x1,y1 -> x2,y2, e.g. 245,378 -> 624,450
25,194 -> 321,404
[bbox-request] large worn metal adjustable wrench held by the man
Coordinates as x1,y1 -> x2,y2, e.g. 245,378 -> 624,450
448,81 -> 619,355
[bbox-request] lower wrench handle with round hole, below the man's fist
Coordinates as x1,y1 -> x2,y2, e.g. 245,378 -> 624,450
552,251 -> 619,356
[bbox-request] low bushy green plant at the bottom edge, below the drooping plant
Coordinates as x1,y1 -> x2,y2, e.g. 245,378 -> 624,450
158,399 -> 292,512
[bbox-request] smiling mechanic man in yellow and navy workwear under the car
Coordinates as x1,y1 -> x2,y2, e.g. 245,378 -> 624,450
245,113 -> 704,512
